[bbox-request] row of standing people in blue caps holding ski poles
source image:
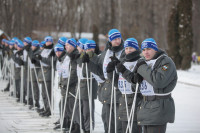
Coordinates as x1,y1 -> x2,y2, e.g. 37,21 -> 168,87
0,29 -> 177,133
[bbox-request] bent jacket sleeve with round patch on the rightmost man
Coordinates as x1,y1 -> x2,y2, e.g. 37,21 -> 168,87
138,56 -> 177,88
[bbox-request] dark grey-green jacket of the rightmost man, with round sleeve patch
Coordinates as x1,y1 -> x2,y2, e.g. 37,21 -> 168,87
137,50 -> 178,125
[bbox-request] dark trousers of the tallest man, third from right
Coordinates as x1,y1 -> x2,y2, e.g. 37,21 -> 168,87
101,104 -> 122,133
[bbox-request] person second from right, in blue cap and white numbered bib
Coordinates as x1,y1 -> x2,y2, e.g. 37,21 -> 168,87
111,38 -> 142,133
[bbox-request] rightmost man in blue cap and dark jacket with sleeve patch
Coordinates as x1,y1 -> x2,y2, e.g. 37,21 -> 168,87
129,38 -> 177,133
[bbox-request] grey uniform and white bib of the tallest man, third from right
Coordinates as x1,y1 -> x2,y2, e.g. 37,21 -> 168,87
88,43 -> 124,133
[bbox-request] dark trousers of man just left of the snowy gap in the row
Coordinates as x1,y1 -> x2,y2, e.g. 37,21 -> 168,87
41,81 -> 51,111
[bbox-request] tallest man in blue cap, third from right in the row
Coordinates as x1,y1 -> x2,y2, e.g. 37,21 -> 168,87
83,29 -> 125,133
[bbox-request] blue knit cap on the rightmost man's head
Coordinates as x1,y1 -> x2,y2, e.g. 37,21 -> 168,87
141,38 -> 158,51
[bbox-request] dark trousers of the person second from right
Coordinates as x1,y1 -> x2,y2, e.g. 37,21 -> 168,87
121,121 -> 142,133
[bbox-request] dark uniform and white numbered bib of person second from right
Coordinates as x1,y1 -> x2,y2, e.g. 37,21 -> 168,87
113,50 -> 142,133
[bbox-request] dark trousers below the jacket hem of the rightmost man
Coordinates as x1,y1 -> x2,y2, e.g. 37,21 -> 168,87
144,124 -> 167,133
